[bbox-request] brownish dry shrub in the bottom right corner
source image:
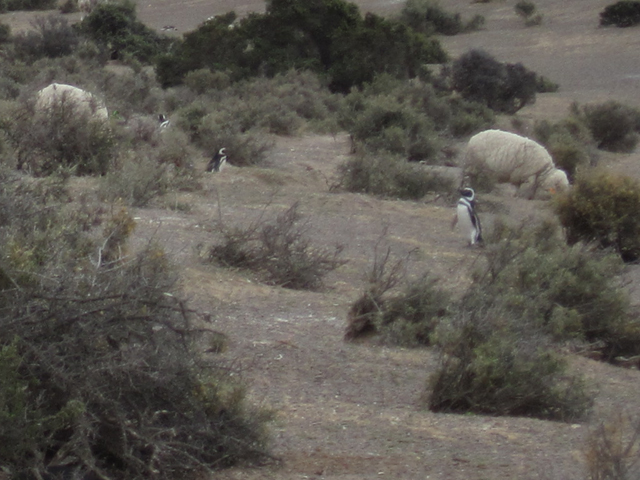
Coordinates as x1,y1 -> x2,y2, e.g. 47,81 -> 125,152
584,413 -> 640,480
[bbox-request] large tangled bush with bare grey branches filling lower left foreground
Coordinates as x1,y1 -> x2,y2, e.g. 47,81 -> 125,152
0,172 -> 267,479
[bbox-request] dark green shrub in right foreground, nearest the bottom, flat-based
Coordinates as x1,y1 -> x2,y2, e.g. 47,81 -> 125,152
425,308 -> 592,421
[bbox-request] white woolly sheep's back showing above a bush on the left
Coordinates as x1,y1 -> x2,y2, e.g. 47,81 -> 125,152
36,83 -> 109,121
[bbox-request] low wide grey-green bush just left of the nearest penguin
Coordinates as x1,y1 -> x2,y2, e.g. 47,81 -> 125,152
338,153 -> 455,200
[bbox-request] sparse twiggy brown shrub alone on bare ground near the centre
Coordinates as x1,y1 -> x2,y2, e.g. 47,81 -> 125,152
207,203 -> 345,290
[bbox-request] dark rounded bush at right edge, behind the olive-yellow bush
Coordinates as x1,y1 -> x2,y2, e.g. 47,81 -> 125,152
574,100 -> 640,152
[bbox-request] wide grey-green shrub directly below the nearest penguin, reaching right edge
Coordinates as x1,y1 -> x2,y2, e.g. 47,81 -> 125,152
478,219 -> 640,350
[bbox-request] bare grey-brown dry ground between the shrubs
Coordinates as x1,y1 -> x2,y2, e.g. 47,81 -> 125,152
0,0 -> 640,480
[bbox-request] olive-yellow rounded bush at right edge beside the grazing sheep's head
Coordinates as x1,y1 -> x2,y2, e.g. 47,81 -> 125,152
556,170 -> 640,262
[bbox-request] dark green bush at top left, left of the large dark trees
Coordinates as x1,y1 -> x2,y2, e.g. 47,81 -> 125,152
78,1 -> 171,63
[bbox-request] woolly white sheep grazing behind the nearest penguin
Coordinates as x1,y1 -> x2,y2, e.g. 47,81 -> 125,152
463,130 -> 569,199
